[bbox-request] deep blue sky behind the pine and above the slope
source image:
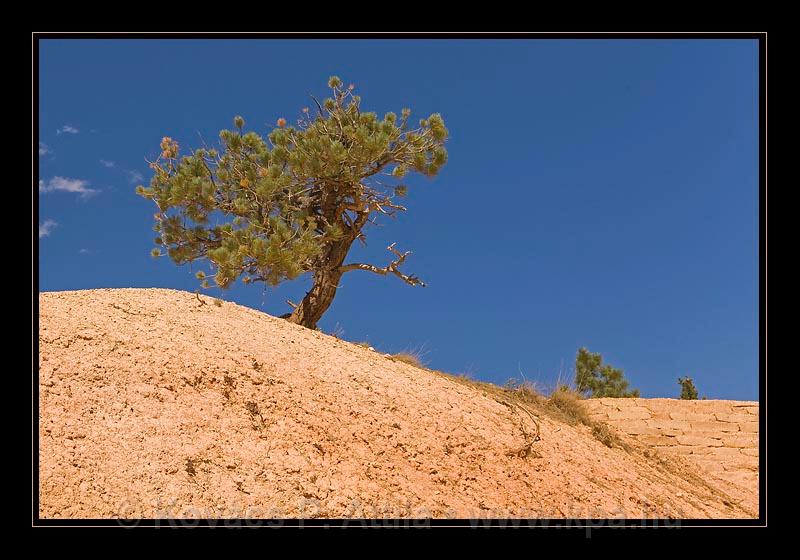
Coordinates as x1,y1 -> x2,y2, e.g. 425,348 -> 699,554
34,39 -> 758,399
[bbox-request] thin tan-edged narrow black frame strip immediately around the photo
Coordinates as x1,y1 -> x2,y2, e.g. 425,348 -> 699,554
31,32 -> 767,537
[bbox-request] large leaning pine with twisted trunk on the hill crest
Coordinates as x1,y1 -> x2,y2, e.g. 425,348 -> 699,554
137,76 -> 448,328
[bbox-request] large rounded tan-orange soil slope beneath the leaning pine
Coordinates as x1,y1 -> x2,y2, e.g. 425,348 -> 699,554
39,289 -> 757,518
